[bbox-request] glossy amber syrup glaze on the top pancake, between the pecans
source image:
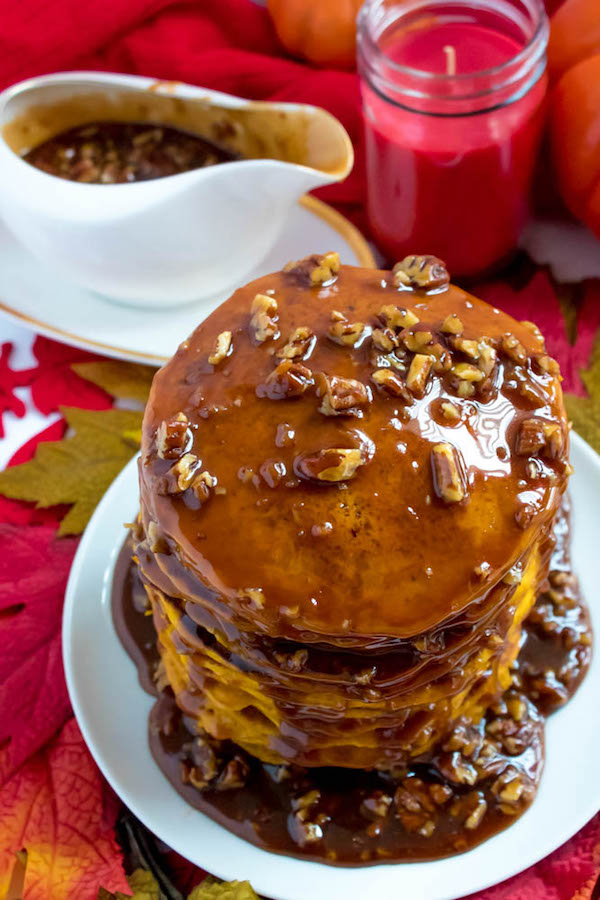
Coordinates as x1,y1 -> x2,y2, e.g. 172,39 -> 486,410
140,266 -> 568,647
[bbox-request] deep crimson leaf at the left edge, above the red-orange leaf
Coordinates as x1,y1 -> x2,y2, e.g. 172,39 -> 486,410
0,524 -> 77,785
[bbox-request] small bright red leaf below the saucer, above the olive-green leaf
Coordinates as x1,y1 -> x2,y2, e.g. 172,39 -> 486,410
31,336 -> 113,415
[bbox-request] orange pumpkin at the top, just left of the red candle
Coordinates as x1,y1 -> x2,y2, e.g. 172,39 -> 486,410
267,0 -> 362,69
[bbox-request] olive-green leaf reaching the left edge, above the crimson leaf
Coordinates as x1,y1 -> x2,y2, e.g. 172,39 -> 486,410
0,408 -> 142,535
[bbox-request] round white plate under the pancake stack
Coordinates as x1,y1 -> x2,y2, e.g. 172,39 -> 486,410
63,435 -> 600,900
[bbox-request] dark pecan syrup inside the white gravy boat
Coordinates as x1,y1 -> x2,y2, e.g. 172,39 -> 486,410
23,122 -> 238,184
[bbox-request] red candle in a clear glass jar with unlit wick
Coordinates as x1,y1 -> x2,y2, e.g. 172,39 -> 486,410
358,0 -> 548,277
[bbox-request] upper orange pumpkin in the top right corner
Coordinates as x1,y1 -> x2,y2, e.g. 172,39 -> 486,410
548,0 -> 600,79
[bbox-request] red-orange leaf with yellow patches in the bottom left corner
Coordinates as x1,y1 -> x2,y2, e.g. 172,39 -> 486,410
0,719 -> 130,900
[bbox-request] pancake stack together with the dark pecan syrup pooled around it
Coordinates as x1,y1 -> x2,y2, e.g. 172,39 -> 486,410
115,253 -> 591,864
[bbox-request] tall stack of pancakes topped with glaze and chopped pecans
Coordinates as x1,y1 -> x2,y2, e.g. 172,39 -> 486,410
135,254 -> 569,771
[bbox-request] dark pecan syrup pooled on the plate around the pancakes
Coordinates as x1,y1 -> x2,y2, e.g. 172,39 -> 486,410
113,509 -> 591,865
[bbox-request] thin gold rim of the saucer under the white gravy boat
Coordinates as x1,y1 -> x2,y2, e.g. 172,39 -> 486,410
0,194 -> 377,366
